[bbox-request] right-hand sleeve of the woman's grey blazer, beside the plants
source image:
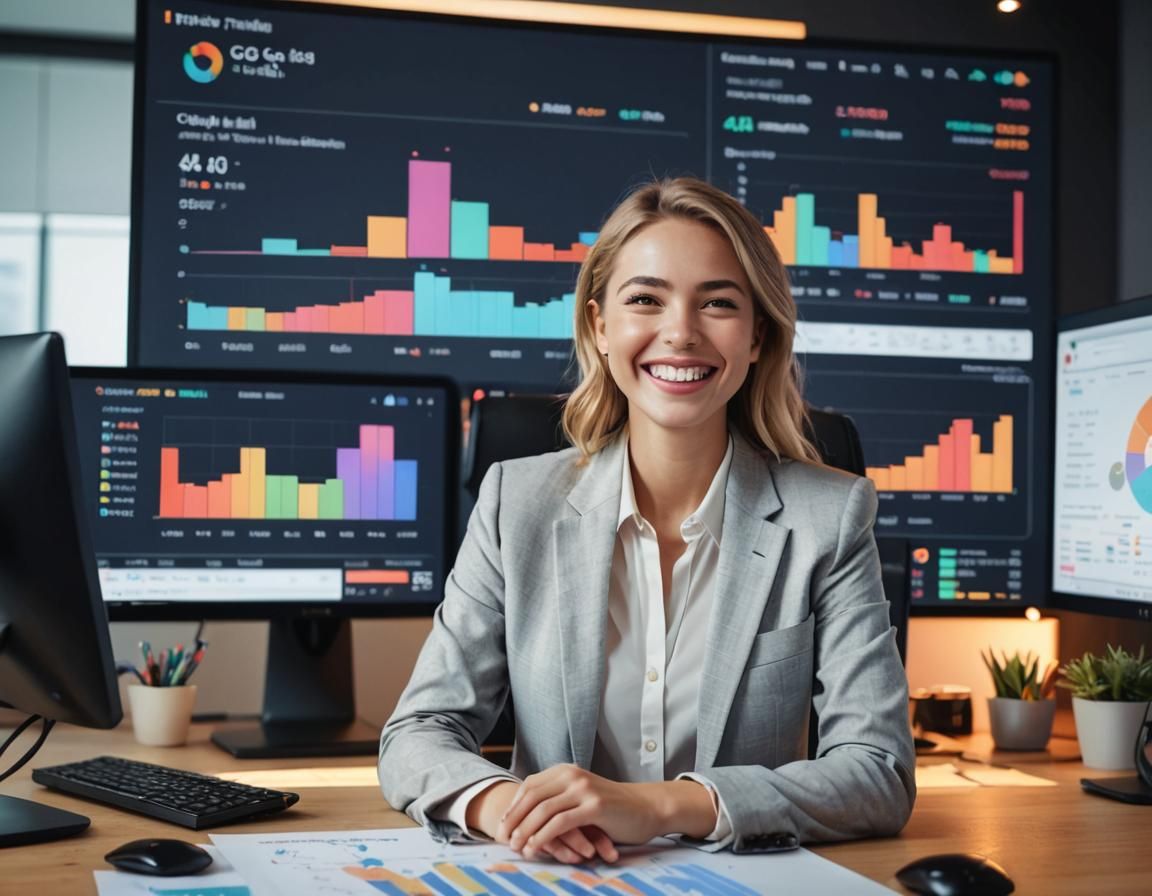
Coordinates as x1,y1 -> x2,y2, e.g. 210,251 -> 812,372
681,479 -> 916,849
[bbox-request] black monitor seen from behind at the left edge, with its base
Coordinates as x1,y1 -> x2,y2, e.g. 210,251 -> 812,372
0,333 -> 121,846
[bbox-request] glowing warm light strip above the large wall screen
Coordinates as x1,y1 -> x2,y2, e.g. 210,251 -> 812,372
292,0 -> 808,40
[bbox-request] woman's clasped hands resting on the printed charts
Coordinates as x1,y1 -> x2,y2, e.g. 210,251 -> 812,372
495,765 -> 666,863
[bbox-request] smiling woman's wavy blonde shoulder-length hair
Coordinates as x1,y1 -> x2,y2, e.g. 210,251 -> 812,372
562,177 -> 820,463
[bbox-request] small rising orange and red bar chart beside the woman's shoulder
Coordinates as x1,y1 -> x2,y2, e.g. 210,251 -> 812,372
865,415 -> 1014,494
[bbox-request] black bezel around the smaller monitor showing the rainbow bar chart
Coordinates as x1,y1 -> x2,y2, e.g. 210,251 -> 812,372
69,366 -> 462,622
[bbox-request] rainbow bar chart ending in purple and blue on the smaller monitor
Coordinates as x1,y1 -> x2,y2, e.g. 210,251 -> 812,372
159,424 -> 418,521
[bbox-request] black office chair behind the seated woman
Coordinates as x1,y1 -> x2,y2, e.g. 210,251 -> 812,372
461,395 -> 908,765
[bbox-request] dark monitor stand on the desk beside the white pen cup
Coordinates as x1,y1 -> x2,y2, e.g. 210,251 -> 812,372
212,617 -> 380,759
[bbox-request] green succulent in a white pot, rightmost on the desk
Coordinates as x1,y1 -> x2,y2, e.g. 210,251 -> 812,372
1059,644 -> 1152,769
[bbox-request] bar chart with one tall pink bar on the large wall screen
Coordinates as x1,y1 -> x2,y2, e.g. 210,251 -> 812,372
181,159 -> 598,264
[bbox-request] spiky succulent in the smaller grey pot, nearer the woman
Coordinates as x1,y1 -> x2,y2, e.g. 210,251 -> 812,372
980,647 -> 1056,750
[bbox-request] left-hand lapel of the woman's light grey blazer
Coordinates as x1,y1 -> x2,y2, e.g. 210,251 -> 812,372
552,439 -> 624,768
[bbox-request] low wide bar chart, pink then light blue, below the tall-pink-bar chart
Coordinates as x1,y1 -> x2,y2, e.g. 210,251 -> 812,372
185,271 -> 576,340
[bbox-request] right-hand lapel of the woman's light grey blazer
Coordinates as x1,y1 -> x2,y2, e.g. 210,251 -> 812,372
696,435 -> 789,768
